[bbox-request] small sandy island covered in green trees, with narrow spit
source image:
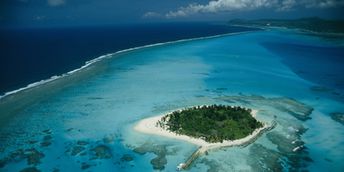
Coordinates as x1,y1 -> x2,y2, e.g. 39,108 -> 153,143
134,104 -> 272,169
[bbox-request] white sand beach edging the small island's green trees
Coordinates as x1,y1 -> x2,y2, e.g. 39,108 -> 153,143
134,110 -> 269,150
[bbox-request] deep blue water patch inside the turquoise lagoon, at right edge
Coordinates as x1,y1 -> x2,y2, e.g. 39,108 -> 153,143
263,42 -> 344,91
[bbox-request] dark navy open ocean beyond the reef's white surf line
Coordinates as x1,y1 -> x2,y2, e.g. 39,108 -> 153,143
0,23 -> 256,94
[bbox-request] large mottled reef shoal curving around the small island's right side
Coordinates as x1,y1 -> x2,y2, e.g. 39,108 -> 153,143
216,94 -> 313,171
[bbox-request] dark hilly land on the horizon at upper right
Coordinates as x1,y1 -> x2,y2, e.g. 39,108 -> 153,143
228,17 -> 344,37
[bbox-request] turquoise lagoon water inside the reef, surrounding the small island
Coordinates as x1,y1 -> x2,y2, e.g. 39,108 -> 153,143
0,30 -> 344,171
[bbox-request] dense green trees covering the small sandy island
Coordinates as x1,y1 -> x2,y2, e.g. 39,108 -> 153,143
157,105 -> 263,143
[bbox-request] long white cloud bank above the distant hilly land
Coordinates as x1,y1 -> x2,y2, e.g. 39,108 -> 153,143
165,0 -> 344,18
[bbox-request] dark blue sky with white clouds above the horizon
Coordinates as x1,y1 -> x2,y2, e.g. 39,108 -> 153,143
0,0 -> 344,27
